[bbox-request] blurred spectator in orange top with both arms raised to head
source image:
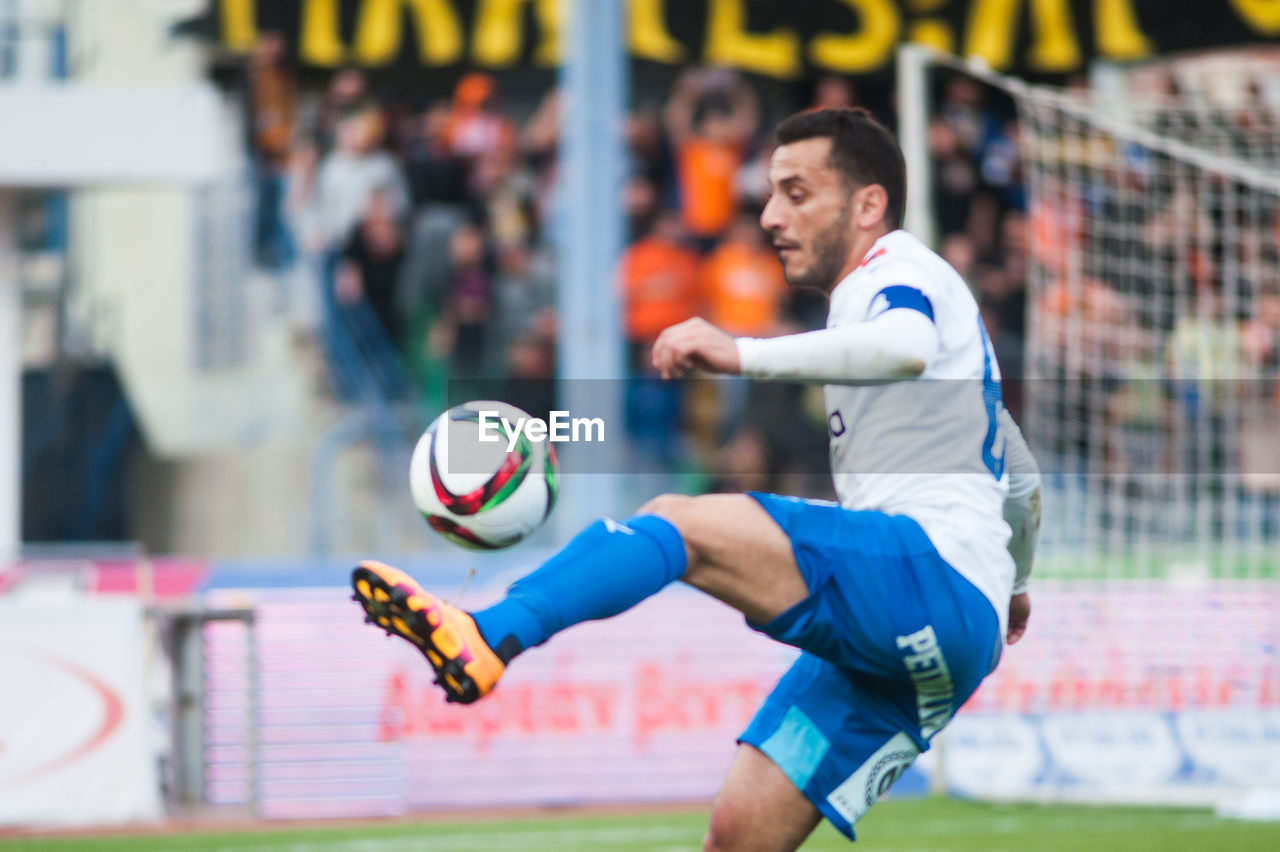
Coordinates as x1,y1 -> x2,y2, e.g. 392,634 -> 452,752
663,69 -> 759,249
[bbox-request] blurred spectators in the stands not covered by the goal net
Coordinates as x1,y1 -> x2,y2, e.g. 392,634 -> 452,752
247,35 -> 1049,494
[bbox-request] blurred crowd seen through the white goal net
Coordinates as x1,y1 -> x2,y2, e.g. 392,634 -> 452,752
1030,72 -> 1280,491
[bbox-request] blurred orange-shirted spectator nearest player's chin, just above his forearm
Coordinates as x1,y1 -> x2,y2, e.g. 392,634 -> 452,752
701,212 -> 787,338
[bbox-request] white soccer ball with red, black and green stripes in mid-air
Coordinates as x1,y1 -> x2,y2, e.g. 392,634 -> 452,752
408,399 -> 558,550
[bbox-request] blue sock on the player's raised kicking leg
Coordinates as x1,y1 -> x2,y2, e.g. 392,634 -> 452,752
471,514 -> 686,663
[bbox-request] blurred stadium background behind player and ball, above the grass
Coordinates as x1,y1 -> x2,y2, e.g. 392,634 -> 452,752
0,0 -> 1280,848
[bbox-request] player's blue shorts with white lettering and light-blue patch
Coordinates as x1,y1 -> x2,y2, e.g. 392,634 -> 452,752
740,493 -> 1002,839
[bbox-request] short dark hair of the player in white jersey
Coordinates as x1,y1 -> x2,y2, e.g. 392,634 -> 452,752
773,106 -> 906,229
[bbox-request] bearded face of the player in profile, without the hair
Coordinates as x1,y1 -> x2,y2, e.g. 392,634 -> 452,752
760,137 -> 854,290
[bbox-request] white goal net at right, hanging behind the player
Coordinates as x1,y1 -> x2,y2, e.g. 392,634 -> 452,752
1014,54 -> 1280,577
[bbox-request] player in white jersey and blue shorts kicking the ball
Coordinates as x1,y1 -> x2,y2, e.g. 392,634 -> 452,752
352,110 -> 1038,852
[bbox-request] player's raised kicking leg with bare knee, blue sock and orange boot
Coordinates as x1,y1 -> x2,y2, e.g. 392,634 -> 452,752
352,495 -> 808,704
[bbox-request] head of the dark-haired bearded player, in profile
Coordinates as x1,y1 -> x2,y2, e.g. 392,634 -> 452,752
760,109 -> 906,290
